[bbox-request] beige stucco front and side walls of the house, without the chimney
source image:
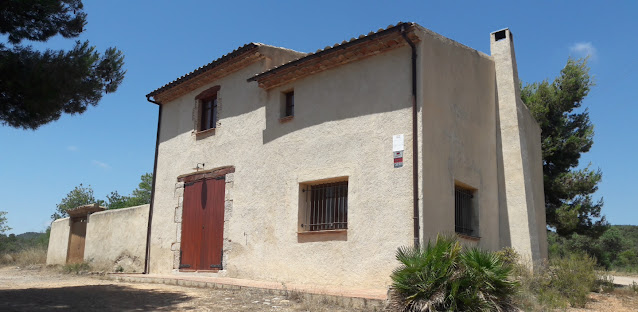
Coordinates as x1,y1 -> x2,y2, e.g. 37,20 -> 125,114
150,26 -> 542,288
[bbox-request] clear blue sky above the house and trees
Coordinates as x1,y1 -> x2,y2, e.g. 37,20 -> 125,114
0,0 -> 638,233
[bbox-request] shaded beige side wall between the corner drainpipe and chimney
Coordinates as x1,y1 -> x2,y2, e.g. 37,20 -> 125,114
419,27 -> 500,250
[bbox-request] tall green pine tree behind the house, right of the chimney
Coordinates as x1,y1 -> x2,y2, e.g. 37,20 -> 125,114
521,58 -> 608,237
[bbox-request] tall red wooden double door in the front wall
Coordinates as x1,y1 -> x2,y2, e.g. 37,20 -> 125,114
179,176 -> 226,271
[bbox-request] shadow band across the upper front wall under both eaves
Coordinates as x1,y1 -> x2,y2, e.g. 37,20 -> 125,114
160,47 -> 412,144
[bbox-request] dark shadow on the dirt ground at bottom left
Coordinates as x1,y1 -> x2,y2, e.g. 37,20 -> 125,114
0,285 -> 192,311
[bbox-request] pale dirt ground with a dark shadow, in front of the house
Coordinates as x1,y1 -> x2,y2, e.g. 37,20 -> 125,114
0,267 -> 372,312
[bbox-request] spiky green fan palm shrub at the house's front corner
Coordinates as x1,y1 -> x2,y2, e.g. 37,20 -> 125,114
391,235 -> 516,311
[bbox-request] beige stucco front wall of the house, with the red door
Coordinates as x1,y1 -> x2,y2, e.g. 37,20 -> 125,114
151,48 -> 412,287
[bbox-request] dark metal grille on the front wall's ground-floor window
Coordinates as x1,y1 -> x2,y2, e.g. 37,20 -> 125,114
301,181 -> 348,231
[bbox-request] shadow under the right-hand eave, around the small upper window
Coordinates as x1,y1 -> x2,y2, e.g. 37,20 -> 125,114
263,48 -> 412,144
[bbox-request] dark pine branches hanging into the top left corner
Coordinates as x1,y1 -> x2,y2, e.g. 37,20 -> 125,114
0,0 -> 125,129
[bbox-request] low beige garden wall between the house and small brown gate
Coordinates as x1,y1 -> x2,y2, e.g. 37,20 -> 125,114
84,205 -> 149,272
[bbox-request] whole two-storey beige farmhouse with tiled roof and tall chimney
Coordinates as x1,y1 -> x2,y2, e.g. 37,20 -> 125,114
141,23 -> 547,288
